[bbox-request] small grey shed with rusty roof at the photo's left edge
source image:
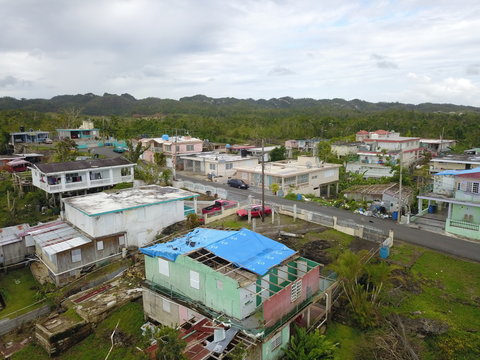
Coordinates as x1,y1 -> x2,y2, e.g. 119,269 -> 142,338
0,224 -> 31,268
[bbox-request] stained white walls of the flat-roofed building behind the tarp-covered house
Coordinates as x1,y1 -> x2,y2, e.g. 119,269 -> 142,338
65,200 -> 185,247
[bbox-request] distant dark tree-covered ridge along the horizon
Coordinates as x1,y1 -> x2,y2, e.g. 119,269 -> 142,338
0,93 -> 480,116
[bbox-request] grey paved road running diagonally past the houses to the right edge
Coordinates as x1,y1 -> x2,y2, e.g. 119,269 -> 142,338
177,174 -> 480,261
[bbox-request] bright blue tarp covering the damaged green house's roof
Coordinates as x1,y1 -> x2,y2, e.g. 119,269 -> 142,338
140,228 -> 295,275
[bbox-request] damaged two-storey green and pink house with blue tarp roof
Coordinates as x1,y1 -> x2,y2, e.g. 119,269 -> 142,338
141,228 -> 334,360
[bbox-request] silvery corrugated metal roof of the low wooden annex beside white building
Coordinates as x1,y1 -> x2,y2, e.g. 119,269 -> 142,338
25,221 -> 92,255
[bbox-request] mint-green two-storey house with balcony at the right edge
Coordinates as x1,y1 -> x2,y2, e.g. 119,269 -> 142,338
417,168 -> 480,240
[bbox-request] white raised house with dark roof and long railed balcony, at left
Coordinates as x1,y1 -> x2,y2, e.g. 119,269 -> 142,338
31,157 -> 135,194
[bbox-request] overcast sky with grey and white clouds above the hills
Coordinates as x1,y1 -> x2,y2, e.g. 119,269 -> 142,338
0,0 -> 480,106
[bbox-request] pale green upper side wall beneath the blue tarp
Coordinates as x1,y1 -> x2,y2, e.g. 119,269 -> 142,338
145,256 -> 242,319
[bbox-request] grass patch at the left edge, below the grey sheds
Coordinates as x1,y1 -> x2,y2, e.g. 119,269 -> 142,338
0,268 -> 42,319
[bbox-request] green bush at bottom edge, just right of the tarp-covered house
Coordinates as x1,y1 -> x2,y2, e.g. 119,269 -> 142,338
284,328 -> 338,360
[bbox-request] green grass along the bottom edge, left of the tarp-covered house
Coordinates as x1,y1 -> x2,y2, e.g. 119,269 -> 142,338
12,302 -> 146,360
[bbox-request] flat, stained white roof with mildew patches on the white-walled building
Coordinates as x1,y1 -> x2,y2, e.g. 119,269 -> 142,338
63,185 -> 199,216
